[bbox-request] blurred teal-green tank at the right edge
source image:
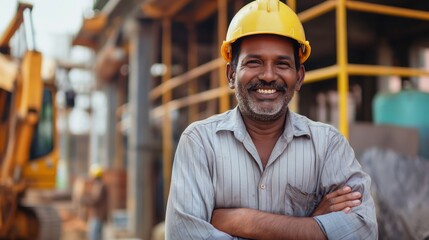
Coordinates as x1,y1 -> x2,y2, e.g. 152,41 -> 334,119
372,90 -> 429,160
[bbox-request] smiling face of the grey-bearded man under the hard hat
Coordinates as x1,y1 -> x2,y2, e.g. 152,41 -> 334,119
227,35 -> 304,121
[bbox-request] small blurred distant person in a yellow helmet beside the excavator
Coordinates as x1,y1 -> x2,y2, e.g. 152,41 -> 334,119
82,165 -> 108,240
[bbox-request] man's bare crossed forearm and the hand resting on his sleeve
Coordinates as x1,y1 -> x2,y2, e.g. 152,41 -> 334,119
211,187 -> 361,239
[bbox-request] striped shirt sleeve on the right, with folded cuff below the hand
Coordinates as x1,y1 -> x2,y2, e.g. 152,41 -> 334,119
315,130 -> 378,239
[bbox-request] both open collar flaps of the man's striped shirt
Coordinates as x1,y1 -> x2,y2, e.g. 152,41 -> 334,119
216,106 -> 311,142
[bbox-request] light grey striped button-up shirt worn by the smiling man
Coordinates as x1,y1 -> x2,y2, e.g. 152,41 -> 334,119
166,108 -> 377,239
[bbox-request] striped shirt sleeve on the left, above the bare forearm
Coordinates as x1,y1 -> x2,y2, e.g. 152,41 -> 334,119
166,131 -> 233,240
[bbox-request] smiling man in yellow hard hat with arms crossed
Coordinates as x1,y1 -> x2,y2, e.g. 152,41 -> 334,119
166,0 -> 378,240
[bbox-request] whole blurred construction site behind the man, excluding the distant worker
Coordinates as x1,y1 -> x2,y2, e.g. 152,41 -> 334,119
0,0 -> 429,239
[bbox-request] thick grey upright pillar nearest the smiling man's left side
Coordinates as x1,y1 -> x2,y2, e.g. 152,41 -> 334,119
127,20 -> 157,240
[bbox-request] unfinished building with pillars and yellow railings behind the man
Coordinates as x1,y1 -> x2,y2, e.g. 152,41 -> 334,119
52,0 -> 429,239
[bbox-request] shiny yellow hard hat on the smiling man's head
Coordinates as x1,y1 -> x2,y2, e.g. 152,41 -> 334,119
221,0 -> 311,63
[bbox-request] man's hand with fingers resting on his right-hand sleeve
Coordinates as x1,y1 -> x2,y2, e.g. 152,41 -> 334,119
311,186 -> 362,217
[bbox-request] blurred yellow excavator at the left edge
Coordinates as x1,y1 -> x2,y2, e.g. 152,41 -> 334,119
0,3 -> 61,240
